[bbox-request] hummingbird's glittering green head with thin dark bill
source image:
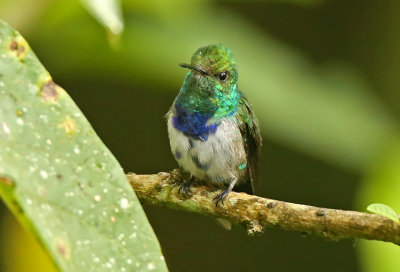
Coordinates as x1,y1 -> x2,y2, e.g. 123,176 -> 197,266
178,44 -> 240,119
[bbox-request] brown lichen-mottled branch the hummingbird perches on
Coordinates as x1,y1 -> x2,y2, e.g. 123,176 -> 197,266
127,170 -> 400,245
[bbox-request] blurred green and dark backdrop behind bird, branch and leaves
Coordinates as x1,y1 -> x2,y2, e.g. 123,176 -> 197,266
0,0 -> 400,272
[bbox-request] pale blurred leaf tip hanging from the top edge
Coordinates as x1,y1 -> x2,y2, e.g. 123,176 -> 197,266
81,0 -> 124,35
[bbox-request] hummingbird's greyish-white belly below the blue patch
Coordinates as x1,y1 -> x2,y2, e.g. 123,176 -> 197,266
168,114 -> 247,186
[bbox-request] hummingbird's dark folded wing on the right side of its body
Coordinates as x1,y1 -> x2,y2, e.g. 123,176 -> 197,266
238,93 -> 262,194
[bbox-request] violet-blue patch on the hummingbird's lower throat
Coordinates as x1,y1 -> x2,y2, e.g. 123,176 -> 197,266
172,103 -> 218,141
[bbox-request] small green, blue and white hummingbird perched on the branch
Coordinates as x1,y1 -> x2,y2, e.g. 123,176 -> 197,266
166,44 -> 262,206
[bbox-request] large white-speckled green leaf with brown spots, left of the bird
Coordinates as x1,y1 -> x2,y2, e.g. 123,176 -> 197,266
0,21 -> 167,271
